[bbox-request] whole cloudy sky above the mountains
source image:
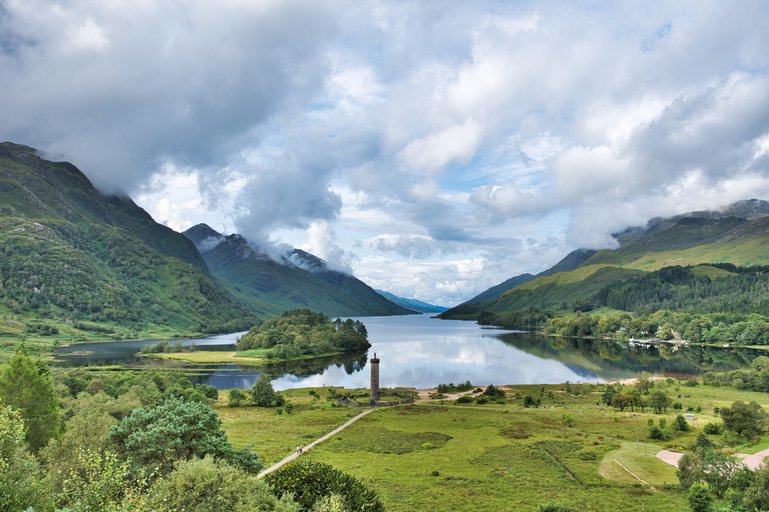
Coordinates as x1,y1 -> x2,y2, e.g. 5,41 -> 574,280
0,0 -> 769,305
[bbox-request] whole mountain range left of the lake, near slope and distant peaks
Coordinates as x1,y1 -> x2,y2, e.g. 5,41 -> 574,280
0,142 -> 412,340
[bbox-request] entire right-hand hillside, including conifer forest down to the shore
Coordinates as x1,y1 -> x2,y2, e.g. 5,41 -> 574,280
442,200 -> 769,344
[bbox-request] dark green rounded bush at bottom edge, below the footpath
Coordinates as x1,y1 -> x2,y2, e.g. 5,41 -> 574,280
265,460 -> 384,512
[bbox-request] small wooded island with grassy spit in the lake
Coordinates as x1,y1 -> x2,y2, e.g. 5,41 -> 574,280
141,309 -> 371,365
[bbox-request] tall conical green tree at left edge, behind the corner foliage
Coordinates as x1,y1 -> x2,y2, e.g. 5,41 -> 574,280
0,348 -> 61,452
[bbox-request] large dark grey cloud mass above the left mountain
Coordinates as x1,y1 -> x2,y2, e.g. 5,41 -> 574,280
0,0 -> 336,191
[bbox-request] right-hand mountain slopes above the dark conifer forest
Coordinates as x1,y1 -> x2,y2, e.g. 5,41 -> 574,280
440,199 -> 769,322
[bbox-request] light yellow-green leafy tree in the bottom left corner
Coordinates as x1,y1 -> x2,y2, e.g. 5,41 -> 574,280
0,404 -> 50,512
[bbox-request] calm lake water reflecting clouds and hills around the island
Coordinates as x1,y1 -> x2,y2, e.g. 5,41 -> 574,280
56,315 -> 757,389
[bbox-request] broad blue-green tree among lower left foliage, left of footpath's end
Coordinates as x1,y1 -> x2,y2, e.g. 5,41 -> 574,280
109,397 -> 262,473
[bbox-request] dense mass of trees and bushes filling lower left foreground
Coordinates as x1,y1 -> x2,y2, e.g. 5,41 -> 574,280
0,350 -> 383,512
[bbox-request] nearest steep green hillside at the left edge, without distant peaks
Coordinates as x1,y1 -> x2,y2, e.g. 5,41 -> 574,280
0,143 -> 254,346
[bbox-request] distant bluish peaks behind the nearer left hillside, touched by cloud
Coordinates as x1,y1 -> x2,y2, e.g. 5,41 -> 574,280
184,224 -> 413,316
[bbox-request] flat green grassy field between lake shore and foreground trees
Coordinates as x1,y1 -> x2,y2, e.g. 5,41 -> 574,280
217,381 -> 769,512
